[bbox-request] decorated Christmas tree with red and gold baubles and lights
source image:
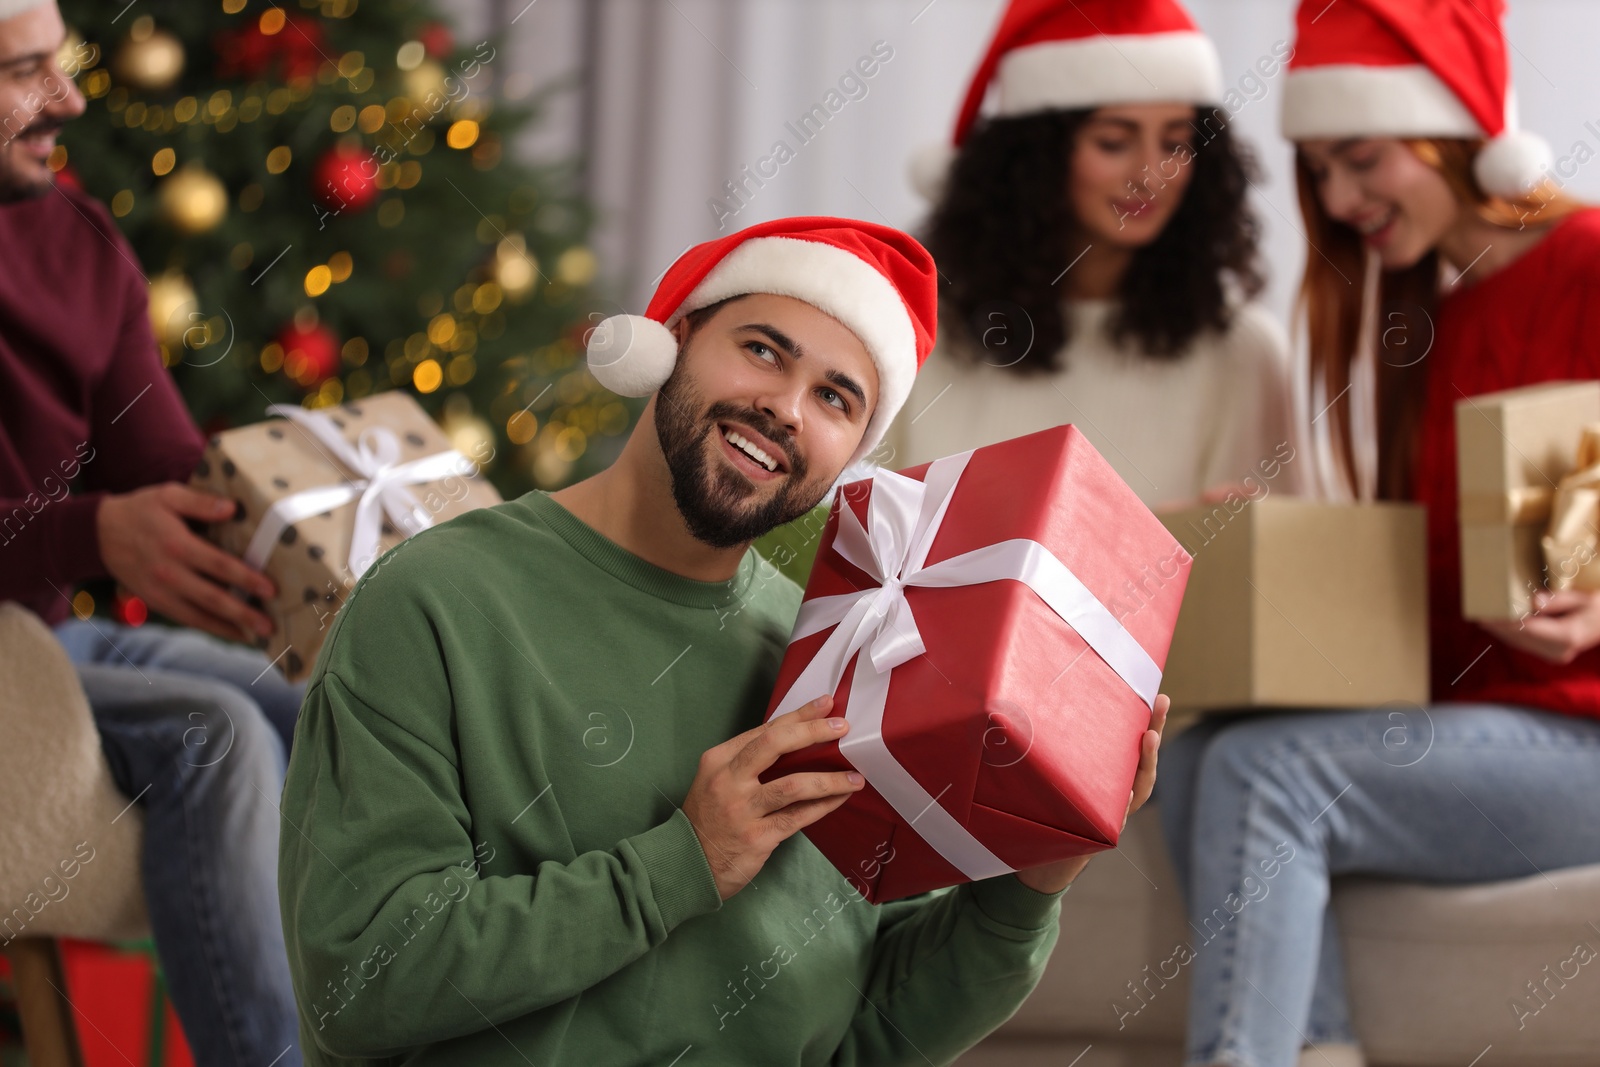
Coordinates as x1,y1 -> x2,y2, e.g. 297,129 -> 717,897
51,0 -> 624,496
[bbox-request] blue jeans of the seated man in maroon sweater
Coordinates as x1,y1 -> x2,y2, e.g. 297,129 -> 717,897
56,619 -> 304,1067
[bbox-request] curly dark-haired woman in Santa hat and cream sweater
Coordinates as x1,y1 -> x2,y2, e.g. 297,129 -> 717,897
891,0 -> 1294,504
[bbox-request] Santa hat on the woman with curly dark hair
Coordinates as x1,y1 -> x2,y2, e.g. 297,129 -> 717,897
912,0 -> 1222,200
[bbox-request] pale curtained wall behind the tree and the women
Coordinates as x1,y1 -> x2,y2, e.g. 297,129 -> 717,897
451,0 -> 1600,326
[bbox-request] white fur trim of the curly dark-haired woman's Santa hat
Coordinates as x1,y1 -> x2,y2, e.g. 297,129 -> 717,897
995,32 -> 1222,115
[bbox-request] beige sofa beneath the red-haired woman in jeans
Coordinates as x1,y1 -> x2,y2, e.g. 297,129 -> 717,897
960,808 -> 1600,1067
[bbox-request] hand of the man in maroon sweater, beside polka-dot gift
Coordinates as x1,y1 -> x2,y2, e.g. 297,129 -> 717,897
94,482 -> 277,641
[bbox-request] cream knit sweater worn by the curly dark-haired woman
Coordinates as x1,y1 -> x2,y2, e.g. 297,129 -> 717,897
882,301 -> 1301,506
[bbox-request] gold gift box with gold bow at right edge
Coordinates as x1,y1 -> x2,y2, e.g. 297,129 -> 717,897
1456,381 -> 1600,619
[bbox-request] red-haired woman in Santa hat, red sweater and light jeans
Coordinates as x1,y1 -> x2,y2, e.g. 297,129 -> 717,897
1160,0 -> 1600,1067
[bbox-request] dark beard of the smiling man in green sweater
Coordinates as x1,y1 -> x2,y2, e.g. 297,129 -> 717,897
656,355 -> 829,549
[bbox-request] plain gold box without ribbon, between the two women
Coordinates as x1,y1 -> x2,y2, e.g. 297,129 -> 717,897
1160,498 -> 1429,710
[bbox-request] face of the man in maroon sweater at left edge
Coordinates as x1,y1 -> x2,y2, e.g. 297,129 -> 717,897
0,3 -> 83,203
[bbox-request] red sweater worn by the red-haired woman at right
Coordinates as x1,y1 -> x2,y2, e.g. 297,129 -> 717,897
1416,210 -> 1600,717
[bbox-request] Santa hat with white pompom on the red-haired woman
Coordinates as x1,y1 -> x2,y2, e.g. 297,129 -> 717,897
1283,0 -> 1550,197
